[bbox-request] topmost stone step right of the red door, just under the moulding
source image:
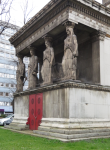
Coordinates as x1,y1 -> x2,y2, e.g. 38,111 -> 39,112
38,126 -> 110,135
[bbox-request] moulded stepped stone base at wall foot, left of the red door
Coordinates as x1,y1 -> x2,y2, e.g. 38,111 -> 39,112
4,117 -> 29,130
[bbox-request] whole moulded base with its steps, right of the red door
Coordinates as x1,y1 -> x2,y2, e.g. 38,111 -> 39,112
33,118 -> 110,142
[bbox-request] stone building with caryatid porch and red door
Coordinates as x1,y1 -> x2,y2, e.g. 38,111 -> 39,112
5,0 -> 110,141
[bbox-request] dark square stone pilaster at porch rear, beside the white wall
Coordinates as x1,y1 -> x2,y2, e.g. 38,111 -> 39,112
92,31 -> 105,84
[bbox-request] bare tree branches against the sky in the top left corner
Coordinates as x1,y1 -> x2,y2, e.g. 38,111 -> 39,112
0,0 -> 13,35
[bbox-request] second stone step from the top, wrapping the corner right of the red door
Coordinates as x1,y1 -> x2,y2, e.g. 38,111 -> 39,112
33,130 -> 110,139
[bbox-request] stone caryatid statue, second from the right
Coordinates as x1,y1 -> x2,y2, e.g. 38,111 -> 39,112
41,37 -> 55,84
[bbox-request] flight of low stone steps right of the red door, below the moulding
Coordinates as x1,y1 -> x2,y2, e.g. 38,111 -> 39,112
33,127 -> 110,142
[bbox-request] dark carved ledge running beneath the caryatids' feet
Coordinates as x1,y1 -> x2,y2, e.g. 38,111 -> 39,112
14,81 -> 110,97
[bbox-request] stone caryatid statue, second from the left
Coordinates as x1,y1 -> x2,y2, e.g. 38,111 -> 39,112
28,46 -> 38,89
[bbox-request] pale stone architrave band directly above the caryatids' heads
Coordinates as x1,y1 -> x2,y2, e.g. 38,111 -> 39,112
13,9 -> 110,53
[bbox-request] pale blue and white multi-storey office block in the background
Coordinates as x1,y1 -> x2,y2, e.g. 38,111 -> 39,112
0,22 -> 28,114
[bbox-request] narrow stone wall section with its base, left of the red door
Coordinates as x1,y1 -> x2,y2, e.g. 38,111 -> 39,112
5,95 -> 29,130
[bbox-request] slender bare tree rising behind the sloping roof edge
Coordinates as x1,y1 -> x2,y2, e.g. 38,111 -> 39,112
21,0 -> 35,24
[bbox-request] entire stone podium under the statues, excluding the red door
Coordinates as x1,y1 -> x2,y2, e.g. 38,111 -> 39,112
6,81 -> 110,142
